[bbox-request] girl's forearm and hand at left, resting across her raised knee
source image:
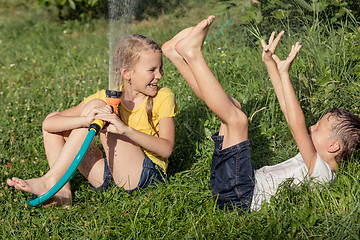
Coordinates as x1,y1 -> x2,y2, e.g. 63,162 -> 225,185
42,101 -> 95,132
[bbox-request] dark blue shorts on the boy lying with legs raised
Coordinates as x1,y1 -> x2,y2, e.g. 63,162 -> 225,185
210,132 -> 255,212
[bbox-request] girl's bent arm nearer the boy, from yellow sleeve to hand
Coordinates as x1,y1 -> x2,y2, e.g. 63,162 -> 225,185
95,106 -> 175,158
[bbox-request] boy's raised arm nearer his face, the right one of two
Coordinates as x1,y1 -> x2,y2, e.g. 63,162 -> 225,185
274,42 -> 317,175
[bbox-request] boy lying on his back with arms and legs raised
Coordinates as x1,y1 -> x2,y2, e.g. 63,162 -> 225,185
162,16 -> 360,211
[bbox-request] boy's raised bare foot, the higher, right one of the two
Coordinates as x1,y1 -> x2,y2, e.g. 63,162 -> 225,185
175,15 -> 215,60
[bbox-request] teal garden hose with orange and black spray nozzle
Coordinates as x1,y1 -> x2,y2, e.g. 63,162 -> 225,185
27,90 -> 121,207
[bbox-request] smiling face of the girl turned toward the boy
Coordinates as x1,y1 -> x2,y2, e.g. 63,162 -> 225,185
130,51 -> 164,96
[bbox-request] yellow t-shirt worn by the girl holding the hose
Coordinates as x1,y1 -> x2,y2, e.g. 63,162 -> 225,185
84,87 -> 178,173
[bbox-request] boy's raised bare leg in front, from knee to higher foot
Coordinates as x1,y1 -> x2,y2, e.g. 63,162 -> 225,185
175,16 -> 248,148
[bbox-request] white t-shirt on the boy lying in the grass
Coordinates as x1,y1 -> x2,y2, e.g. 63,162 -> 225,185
251,153 -> 335,211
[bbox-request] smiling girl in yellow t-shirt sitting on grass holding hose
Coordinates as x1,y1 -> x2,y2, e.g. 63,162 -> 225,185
7,34 -> 177,204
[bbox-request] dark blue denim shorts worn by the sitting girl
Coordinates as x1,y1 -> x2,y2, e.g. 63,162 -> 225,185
93,154 -> 168,194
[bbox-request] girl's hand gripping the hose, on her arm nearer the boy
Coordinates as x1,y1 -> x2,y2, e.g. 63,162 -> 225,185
95,105 -> 128,134
